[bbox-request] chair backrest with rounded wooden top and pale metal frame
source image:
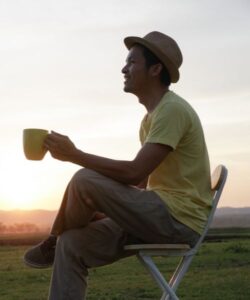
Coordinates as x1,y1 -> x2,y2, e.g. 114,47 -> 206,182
193,165 -> 228,251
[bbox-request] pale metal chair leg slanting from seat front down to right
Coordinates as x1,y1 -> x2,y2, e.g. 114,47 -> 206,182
137,253 -> 179,300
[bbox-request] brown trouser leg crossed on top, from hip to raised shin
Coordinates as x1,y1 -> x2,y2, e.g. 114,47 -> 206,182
53,169 -> 199,245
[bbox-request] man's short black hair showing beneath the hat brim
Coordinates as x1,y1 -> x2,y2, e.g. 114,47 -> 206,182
138,44 -> 171,86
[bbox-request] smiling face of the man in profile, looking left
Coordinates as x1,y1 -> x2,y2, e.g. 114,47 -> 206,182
122,45 -> 149,96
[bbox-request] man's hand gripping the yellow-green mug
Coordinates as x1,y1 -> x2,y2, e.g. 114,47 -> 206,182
44,131 -> 78,161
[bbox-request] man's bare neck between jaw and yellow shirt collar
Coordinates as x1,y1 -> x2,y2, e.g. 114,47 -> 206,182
138,87 -> 168,113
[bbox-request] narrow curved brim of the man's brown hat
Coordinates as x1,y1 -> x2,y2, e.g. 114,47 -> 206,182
124,36 -> 180,83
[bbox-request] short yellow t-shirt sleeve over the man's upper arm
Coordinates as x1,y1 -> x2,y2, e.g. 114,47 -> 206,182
145,103 -> 189,149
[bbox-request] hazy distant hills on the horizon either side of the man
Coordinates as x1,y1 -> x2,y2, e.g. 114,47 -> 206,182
0,207 -> 250,228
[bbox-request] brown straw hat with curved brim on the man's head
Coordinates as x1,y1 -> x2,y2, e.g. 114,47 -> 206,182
124,31 -> 182,82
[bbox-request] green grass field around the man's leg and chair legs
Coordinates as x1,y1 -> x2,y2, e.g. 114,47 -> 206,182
0,233 -> 250,300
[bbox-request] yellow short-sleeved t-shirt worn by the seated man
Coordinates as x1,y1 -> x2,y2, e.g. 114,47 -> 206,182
140,91 -> 212,234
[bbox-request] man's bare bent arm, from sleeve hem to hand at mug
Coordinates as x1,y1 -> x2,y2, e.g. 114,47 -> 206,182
45,132 -> 172,185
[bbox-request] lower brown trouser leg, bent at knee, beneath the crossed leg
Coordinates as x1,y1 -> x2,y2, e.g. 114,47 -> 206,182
49,218 -> 132,300
